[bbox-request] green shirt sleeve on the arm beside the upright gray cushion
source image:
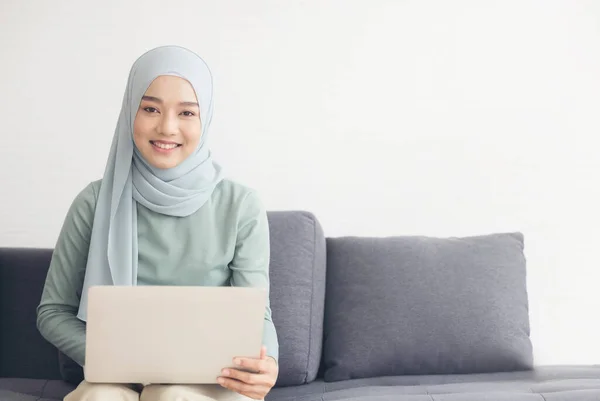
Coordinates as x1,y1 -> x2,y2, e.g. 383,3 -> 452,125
229,192 -> 279,361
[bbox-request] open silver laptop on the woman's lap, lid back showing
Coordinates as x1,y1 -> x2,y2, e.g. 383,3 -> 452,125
84,286 -> 267,384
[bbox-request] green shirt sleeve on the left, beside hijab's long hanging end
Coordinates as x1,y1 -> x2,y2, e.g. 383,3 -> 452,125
37,184 -> 96,366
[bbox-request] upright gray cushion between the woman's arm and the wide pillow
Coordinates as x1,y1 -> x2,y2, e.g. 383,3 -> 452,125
269,212 -> 327,386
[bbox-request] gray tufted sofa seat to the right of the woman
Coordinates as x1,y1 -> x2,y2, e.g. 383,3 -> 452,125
267,365 -> 600,401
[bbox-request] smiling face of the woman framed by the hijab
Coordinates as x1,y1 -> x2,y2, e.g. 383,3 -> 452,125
133,75 -> 202,169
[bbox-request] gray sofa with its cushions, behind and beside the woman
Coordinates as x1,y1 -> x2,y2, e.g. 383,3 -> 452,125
0,212 -> 600,401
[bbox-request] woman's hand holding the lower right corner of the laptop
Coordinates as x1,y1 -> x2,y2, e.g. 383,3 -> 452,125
218,346 -> 279,400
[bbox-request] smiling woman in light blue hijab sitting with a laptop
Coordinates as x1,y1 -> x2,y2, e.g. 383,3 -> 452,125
37,46 -> 278,401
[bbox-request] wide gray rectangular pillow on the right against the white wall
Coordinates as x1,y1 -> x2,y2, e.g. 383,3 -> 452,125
324,233 -> 533,382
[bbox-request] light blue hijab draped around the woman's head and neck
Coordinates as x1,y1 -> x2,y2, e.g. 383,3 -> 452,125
77,46 -> 222,321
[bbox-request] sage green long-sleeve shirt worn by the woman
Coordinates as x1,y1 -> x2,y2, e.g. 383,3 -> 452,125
37,180 -> 279,366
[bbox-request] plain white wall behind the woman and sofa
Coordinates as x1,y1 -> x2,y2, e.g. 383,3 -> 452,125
0,0 -> 600,364
